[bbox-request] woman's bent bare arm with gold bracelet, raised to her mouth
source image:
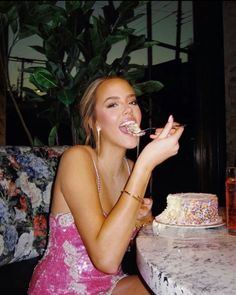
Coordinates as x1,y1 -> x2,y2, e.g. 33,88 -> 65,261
54,117 -> 183,273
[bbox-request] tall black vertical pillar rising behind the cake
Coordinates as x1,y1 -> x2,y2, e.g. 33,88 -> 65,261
193,1 -> 226,205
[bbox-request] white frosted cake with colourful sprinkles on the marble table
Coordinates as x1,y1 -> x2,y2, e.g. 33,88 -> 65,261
155,193 -> 222,226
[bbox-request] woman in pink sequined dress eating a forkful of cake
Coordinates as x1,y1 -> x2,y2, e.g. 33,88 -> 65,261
28,77 -> 183,295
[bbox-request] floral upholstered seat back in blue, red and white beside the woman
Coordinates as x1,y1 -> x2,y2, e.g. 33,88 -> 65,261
0,146 -> 67,266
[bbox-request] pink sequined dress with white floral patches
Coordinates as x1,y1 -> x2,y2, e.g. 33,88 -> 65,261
28,213 -> 126,295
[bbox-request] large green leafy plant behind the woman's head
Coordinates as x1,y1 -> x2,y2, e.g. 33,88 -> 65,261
0,1 -> 163,145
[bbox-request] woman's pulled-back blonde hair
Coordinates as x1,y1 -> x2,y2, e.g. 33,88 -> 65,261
79,76 -> 128,147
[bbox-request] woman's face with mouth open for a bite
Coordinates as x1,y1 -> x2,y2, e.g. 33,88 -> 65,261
95,78 -> 141,148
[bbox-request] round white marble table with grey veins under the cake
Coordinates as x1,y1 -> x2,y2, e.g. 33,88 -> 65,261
136,225 -> 236,295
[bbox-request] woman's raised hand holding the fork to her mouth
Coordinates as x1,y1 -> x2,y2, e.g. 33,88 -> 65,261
136,116 -> 184,172
